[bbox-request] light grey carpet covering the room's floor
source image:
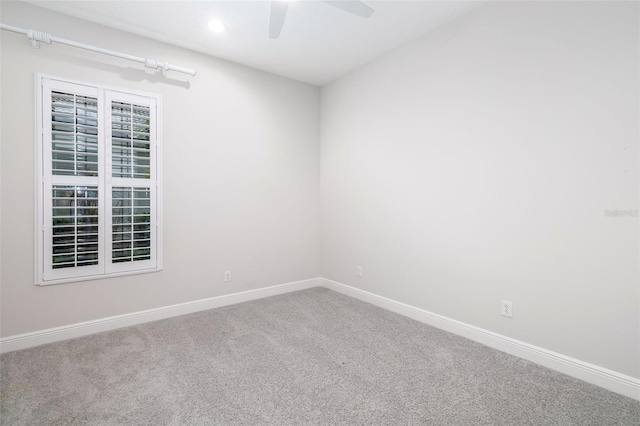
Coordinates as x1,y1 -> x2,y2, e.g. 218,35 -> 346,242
0,288 -> 640,426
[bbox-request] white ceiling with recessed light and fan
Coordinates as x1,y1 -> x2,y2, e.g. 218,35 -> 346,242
28,0 -> 482,86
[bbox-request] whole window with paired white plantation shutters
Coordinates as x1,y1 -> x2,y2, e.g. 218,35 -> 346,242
36,76 -> 162,285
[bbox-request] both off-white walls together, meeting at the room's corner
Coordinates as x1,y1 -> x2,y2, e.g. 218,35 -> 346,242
0,2 -> 640,377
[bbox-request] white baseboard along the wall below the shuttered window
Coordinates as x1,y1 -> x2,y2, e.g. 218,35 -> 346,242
0,278 -> 320,353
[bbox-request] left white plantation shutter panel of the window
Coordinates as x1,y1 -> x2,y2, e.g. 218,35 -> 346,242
40,80 -> 104,280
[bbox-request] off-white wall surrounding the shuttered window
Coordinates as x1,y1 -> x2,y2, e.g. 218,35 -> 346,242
0,2 -> 320,336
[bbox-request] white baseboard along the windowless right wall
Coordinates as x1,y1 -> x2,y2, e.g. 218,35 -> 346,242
320,278 -> 640,400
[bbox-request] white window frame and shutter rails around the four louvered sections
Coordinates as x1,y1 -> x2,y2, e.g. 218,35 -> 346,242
34,73 -> 163,286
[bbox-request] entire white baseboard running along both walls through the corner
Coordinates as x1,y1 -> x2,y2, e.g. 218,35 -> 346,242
0,278 -> 640,400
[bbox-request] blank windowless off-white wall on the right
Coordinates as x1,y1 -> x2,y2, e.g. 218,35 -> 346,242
321,2 -> 640,377
